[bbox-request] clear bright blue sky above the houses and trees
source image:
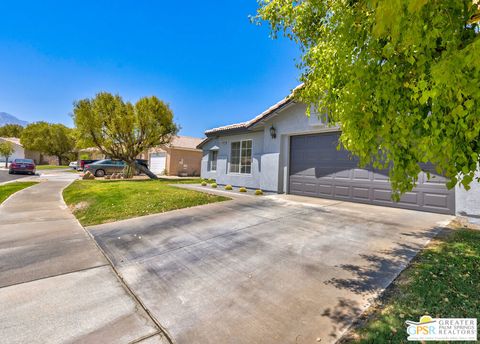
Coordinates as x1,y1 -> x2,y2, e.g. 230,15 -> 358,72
0,0 -> 299,136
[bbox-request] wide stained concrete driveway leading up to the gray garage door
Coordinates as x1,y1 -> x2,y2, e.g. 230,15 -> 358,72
88,196 -> 450,344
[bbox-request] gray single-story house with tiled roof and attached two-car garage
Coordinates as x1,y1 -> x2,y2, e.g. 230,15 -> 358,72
198,87 -> 480,219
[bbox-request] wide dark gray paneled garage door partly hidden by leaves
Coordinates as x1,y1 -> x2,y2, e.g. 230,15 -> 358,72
289,133 -> 455,214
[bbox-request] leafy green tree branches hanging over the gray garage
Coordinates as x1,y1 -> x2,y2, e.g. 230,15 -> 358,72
257,0 -> 480,198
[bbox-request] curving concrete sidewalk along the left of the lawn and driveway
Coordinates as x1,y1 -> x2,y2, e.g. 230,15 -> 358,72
0,175 -> 168,343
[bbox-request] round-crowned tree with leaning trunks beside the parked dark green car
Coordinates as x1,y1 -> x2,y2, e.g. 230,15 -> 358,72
73,92 -> 178,179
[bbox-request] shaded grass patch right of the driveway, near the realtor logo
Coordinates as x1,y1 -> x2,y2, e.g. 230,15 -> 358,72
344,229 -> 480,343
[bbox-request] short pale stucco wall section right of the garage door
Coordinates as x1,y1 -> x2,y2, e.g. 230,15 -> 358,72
455,169 -> 480,224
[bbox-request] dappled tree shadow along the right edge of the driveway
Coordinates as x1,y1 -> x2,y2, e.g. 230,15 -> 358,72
322,227 -> 450,338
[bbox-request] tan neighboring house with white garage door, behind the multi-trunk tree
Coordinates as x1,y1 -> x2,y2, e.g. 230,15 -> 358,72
149,136 -> 202,176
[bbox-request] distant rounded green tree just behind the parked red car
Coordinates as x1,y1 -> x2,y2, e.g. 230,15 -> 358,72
20,122 -> 75,165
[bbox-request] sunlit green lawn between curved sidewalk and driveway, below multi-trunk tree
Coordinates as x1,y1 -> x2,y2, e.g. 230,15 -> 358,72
63,180 -> 228,226
